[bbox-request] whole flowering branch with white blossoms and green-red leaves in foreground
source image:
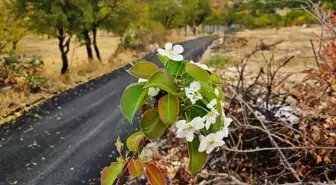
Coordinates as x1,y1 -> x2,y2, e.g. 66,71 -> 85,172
102,43 -> 232,185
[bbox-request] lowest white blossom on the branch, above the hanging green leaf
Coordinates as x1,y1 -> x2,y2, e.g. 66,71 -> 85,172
198,131 -> 225,154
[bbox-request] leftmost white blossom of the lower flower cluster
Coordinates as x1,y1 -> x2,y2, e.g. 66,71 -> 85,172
176,117 -> 204,142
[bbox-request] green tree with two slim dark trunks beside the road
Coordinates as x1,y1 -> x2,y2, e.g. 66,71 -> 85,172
72,0 -> 142,61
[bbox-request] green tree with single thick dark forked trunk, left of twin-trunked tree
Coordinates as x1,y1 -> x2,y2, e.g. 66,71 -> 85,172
17,0 -> 78,74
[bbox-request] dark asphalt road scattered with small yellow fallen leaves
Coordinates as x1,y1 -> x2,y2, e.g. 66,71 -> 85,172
0,37 -> 215,185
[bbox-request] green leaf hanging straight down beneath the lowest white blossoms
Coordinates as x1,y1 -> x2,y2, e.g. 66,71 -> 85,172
188,138 -> 208,175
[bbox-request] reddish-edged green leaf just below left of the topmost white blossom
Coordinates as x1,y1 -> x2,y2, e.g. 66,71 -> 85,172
128,62 -> 159,79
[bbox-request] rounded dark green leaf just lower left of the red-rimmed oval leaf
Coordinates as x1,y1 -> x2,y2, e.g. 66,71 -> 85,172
141,108 -> 166,139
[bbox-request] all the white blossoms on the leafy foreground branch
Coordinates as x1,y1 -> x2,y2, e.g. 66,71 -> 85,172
159,43 -> 232,154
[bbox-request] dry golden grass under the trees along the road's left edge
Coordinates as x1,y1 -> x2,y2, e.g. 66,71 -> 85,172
0,32 -> 205,125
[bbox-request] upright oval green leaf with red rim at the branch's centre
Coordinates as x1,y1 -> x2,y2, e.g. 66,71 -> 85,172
158,94 -> 180,127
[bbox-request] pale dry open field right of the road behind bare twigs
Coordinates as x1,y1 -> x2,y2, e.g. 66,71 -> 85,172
203,26 -> 321,79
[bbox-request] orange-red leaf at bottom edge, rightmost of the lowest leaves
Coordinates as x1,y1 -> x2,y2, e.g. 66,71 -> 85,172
145,163 -> 167,185
